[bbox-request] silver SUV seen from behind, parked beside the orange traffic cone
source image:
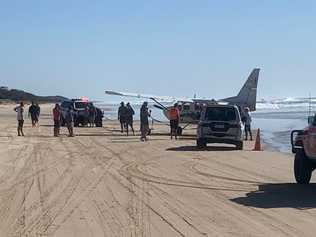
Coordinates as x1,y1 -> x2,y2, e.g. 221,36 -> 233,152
197,105 -> 243,150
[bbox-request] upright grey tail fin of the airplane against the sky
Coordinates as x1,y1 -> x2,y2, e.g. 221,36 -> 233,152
223,68 -> 260,111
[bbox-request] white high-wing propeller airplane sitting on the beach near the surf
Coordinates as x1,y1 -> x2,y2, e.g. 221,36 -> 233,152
105,68 -> 260,135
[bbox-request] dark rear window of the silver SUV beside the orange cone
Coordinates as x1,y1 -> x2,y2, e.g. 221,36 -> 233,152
205,107 -> 237,121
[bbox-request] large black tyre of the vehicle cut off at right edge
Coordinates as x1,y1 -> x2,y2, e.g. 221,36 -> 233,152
294,150 -> 313,184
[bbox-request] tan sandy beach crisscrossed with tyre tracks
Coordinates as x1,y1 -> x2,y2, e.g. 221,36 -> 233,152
0,105 -> 316,237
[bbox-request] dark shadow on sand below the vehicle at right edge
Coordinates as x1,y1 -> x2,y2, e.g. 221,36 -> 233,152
231,183 -> 316,209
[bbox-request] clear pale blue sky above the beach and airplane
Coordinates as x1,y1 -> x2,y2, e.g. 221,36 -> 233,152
0,0 -> 316,99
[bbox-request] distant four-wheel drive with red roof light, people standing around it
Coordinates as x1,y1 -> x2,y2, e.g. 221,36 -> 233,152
61,99 -> 93,127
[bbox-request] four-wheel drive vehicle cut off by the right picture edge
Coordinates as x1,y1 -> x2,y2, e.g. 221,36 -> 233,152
291,116 -> 316,184
